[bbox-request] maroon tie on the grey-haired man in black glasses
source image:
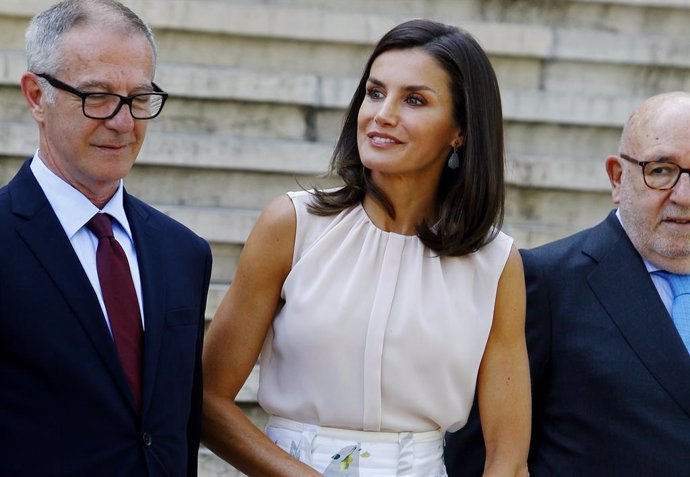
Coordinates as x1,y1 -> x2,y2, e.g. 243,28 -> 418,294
86,213 -> 144,407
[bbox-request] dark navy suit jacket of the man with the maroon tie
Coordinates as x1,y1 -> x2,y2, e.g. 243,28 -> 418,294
0,161 -> 211,477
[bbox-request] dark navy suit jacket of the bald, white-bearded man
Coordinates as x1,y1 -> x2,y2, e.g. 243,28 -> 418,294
446,212 -> 690,477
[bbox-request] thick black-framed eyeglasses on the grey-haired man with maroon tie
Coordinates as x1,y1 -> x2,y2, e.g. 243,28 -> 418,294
36,73 -> 168,119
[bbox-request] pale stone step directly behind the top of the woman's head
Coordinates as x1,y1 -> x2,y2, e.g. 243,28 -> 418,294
0,0 -> 690,67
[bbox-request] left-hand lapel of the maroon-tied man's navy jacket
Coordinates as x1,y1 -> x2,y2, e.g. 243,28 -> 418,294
9,161 -> 134,406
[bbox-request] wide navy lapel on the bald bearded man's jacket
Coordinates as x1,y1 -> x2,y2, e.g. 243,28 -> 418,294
583,214 -> 690,416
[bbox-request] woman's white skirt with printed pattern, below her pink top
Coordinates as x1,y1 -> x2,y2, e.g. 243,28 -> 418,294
266,416 -> 447,477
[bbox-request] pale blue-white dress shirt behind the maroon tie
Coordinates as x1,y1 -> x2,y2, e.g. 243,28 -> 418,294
31,151 -> 144,333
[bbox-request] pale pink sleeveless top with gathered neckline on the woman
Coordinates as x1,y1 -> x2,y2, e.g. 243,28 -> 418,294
259,191 -> 512,432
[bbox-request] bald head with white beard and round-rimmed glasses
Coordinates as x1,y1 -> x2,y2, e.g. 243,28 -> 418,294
606,92 -> 690,274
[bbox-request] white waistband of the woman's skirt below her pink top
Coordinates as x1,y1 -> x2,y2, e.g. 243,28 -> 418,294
267,416 -> 443,444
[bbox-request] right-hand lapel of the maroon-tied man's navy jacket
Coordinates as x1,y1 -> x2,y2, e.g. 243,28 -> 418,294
124,192 -> 167,413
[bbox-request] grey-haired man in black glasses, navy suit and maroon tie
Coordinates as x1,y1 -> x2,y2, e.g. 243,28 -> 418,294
0,0 -> 211,477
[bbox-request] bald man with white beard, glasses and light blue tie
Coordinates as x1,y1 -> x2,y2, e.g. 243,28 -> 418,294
446,92 -> 690,477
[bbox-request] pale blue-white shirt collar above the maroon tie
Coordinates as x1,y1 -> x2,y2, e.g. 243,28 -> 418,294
31,151 -> 132,240
